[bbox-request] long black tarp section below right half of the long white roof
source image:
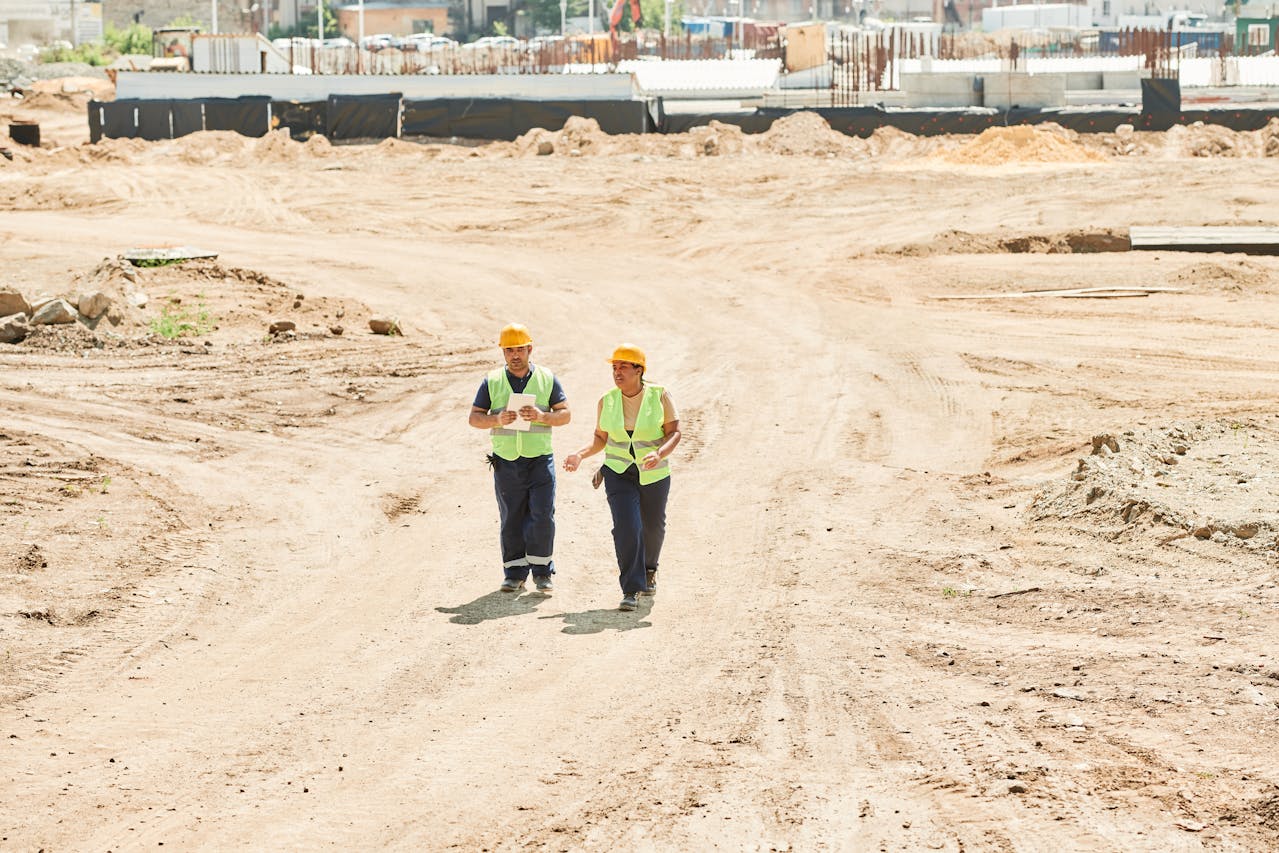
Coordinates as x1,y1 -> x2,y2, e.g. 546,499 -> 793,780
403,97 -> 657,141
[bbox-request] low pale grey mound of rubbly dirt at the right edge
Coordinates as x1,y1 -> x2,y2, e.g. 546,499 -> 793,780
1028,416 -> 1279,551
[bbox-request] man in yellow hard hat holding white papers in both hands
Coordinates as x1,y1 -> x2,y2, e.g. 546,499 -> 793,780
469,324 -> 572,595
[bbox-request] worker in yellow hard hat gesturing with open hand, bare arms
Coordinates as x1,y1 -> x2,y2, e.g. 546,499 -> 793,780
564,344 -> 679,610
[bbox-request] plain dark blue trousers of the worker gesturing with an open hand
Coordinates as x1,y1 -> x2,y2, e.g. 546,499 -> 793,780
604,466 -> 670,595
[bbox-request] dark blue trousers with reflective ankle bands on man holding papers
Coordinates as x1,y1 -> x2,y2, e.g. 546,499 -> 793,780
492,455 -> 555,581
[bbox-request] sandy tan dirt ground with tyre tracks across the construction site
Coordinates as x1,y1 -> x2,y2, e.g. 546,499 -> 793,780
0,90 -> 1279,852
